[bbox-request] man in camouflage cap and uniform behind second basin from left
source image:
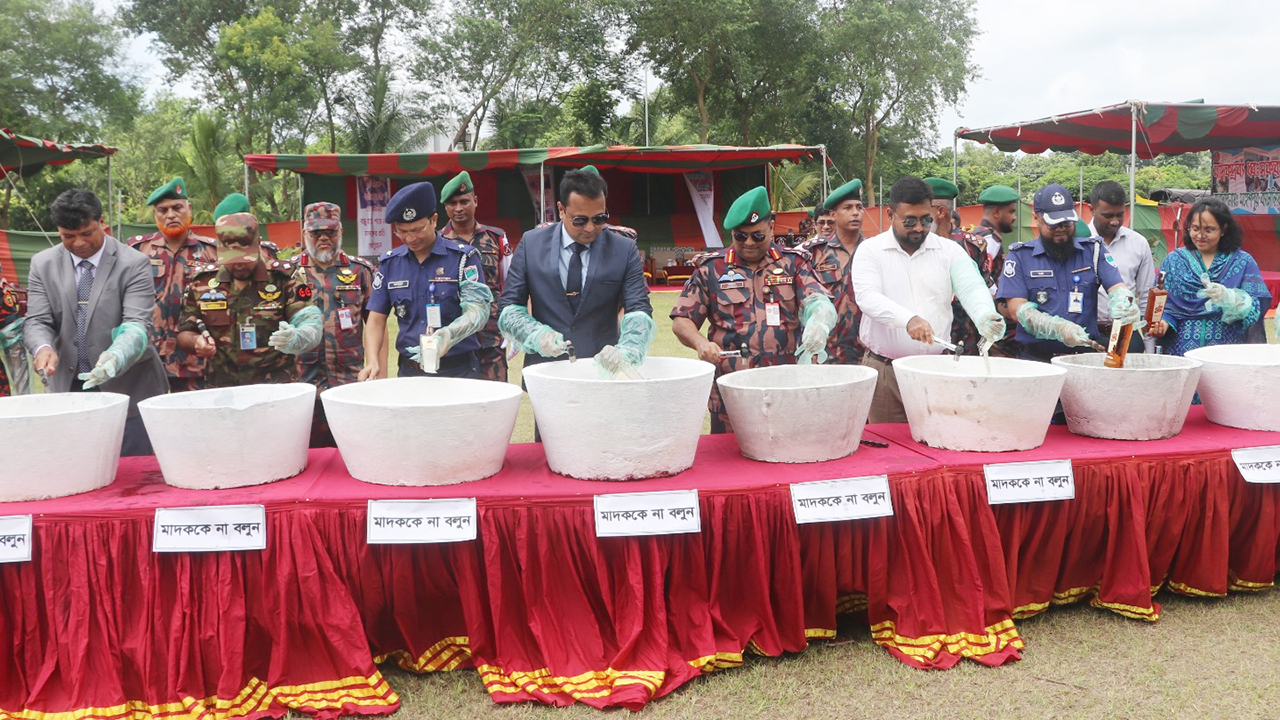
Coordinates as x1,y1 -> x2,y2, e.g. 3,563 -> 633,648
178,213 -> 324,387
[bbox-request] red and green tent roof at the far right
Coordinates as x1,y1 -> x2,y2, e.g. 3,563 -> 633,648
955,100 -> 1280,159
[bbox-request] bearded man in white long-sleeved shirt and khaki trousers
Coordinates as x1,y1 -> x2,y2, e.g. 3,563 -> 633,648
850,177 -> 1005,423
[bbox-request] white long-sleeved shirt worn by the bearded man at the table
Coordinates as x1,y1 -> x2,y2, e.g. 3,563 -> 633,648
849,229 -> 977,360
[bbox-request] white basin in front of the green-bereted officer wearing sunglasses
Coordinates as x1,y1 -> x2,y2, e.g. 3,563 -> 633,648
716,365 -> 876,462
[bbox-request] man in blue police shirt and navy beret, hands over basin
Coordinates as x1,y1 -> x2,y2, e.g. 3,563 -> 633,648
360,182 -> 493,380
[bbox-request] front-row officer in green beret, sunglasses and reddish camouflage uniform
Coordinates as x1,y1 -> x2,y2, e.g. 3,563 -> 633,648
671,187 -> 836,433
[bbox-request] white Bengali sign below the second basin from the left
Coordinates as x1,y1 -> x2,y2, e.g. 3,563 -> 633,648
151,505 -> 266,552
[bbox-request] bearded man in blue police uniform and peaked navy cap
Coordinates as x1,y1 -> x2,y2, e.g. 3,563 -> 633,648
996,184 -> 1139,363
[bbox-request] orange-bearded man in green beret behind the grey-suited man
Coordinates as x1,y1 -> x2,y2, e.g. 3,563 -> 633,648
127,178 -> 218,392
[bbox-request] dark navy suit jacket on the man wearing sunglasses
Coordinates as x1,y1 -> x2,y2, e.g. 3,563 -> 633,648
499,223 -> 653,364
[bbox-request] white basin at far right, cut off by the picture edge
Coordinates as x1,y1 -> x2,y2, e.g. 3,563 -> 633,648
1187,345 -> 1280,430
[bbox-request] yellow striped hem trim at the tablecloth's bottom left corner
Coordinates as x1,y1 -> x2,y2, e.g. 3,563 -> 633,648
0,671 -> 399,720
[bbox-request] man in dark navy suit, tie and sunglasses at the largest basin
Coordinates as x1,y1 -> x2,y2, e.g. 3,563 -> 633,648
498,165 -> 657,375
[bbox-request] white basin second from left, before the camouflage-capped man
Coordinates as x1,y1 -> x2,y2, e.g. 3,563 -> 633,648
138,383 -> 316,489
